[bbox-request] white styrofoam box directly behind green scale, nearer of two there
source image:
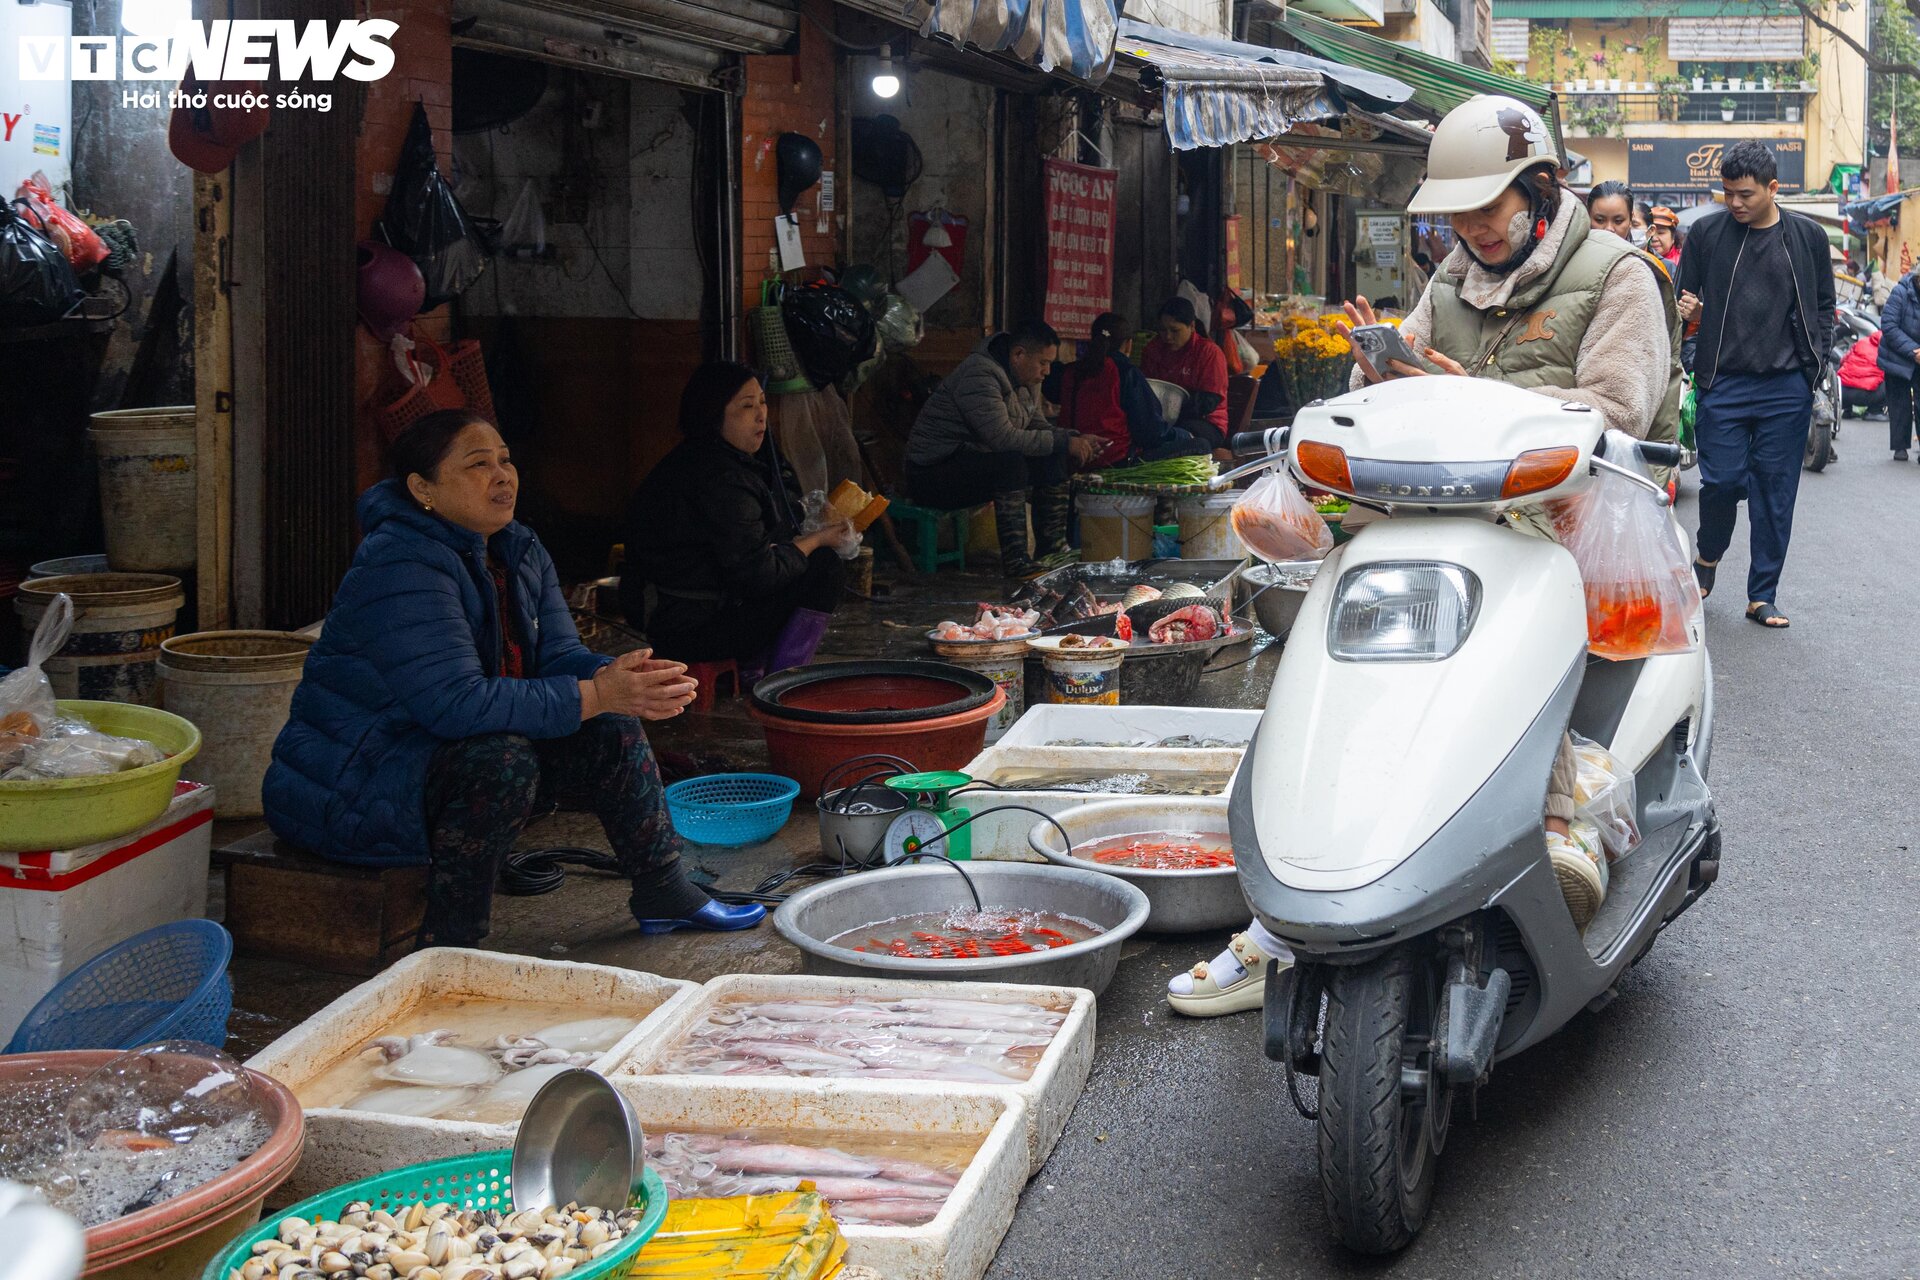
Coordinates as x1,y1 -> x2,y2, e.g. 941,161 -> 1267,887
954,740 -> 1258,862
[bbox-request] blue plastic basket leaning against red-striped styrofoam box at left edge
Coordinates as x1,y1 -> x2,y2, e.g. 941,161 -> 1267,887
6,919 -> 234,1054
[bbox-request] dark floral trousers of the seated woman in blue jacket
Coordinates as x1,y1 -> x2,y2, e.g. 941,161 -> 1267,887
424,716 -> 680,946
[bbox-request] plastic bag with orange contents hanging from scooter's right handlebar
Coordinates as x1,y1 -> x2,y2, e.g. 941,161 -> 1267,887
1548,436 -> 1699,662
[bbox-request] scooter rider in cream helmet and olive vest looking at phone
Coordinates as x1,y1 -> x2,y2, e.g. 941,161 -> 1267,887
1167,96 -> 1680,1017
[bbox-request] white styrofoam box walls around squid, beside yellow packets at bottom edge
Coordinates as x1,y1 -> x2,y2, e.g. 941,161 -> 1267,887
614,1077 -> 1029,1280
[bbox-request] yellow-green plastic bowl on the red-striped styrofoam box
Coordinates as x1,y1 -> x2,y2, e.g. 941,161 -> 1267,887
0,699 -> 200,854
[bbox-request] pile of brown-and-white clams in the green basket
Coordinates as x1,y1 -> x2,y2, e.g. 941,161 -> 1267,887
227,1199 -> 639,1280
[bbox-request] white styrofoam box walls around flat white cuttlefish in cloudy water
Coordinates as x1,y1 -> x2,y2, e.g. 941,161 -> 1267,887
246,946 -> 699,1201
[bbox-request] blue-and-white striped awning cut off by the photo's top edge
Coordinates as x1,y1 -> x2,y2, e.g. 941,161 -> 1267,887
841,0 -> 1119,83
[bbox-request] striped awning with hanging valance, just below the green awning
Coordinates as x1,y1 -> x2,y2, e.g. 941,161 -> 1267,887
1114,19 -> 1413,152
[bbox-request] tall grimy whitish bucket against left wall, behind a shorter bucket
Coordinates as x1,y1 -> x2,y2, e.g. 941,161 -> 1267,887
86,405 -> 200,574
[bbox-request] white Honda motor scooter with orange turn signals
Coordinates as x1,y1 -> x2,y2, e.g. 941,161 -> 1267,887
1231,378 -> 1720,1253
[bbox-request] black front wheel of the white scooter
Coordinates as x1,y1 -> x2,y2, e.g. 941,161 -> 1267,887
1319,942 -> 1453,1253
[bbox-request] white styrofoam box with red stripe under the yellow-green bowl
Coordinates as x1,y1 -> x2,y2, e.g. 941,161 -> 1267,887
0,783 -> 213,1044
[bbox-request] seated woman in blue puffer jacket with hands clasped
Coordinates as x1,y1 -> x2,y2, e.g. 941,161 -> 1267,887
263,411 -> 766,946
